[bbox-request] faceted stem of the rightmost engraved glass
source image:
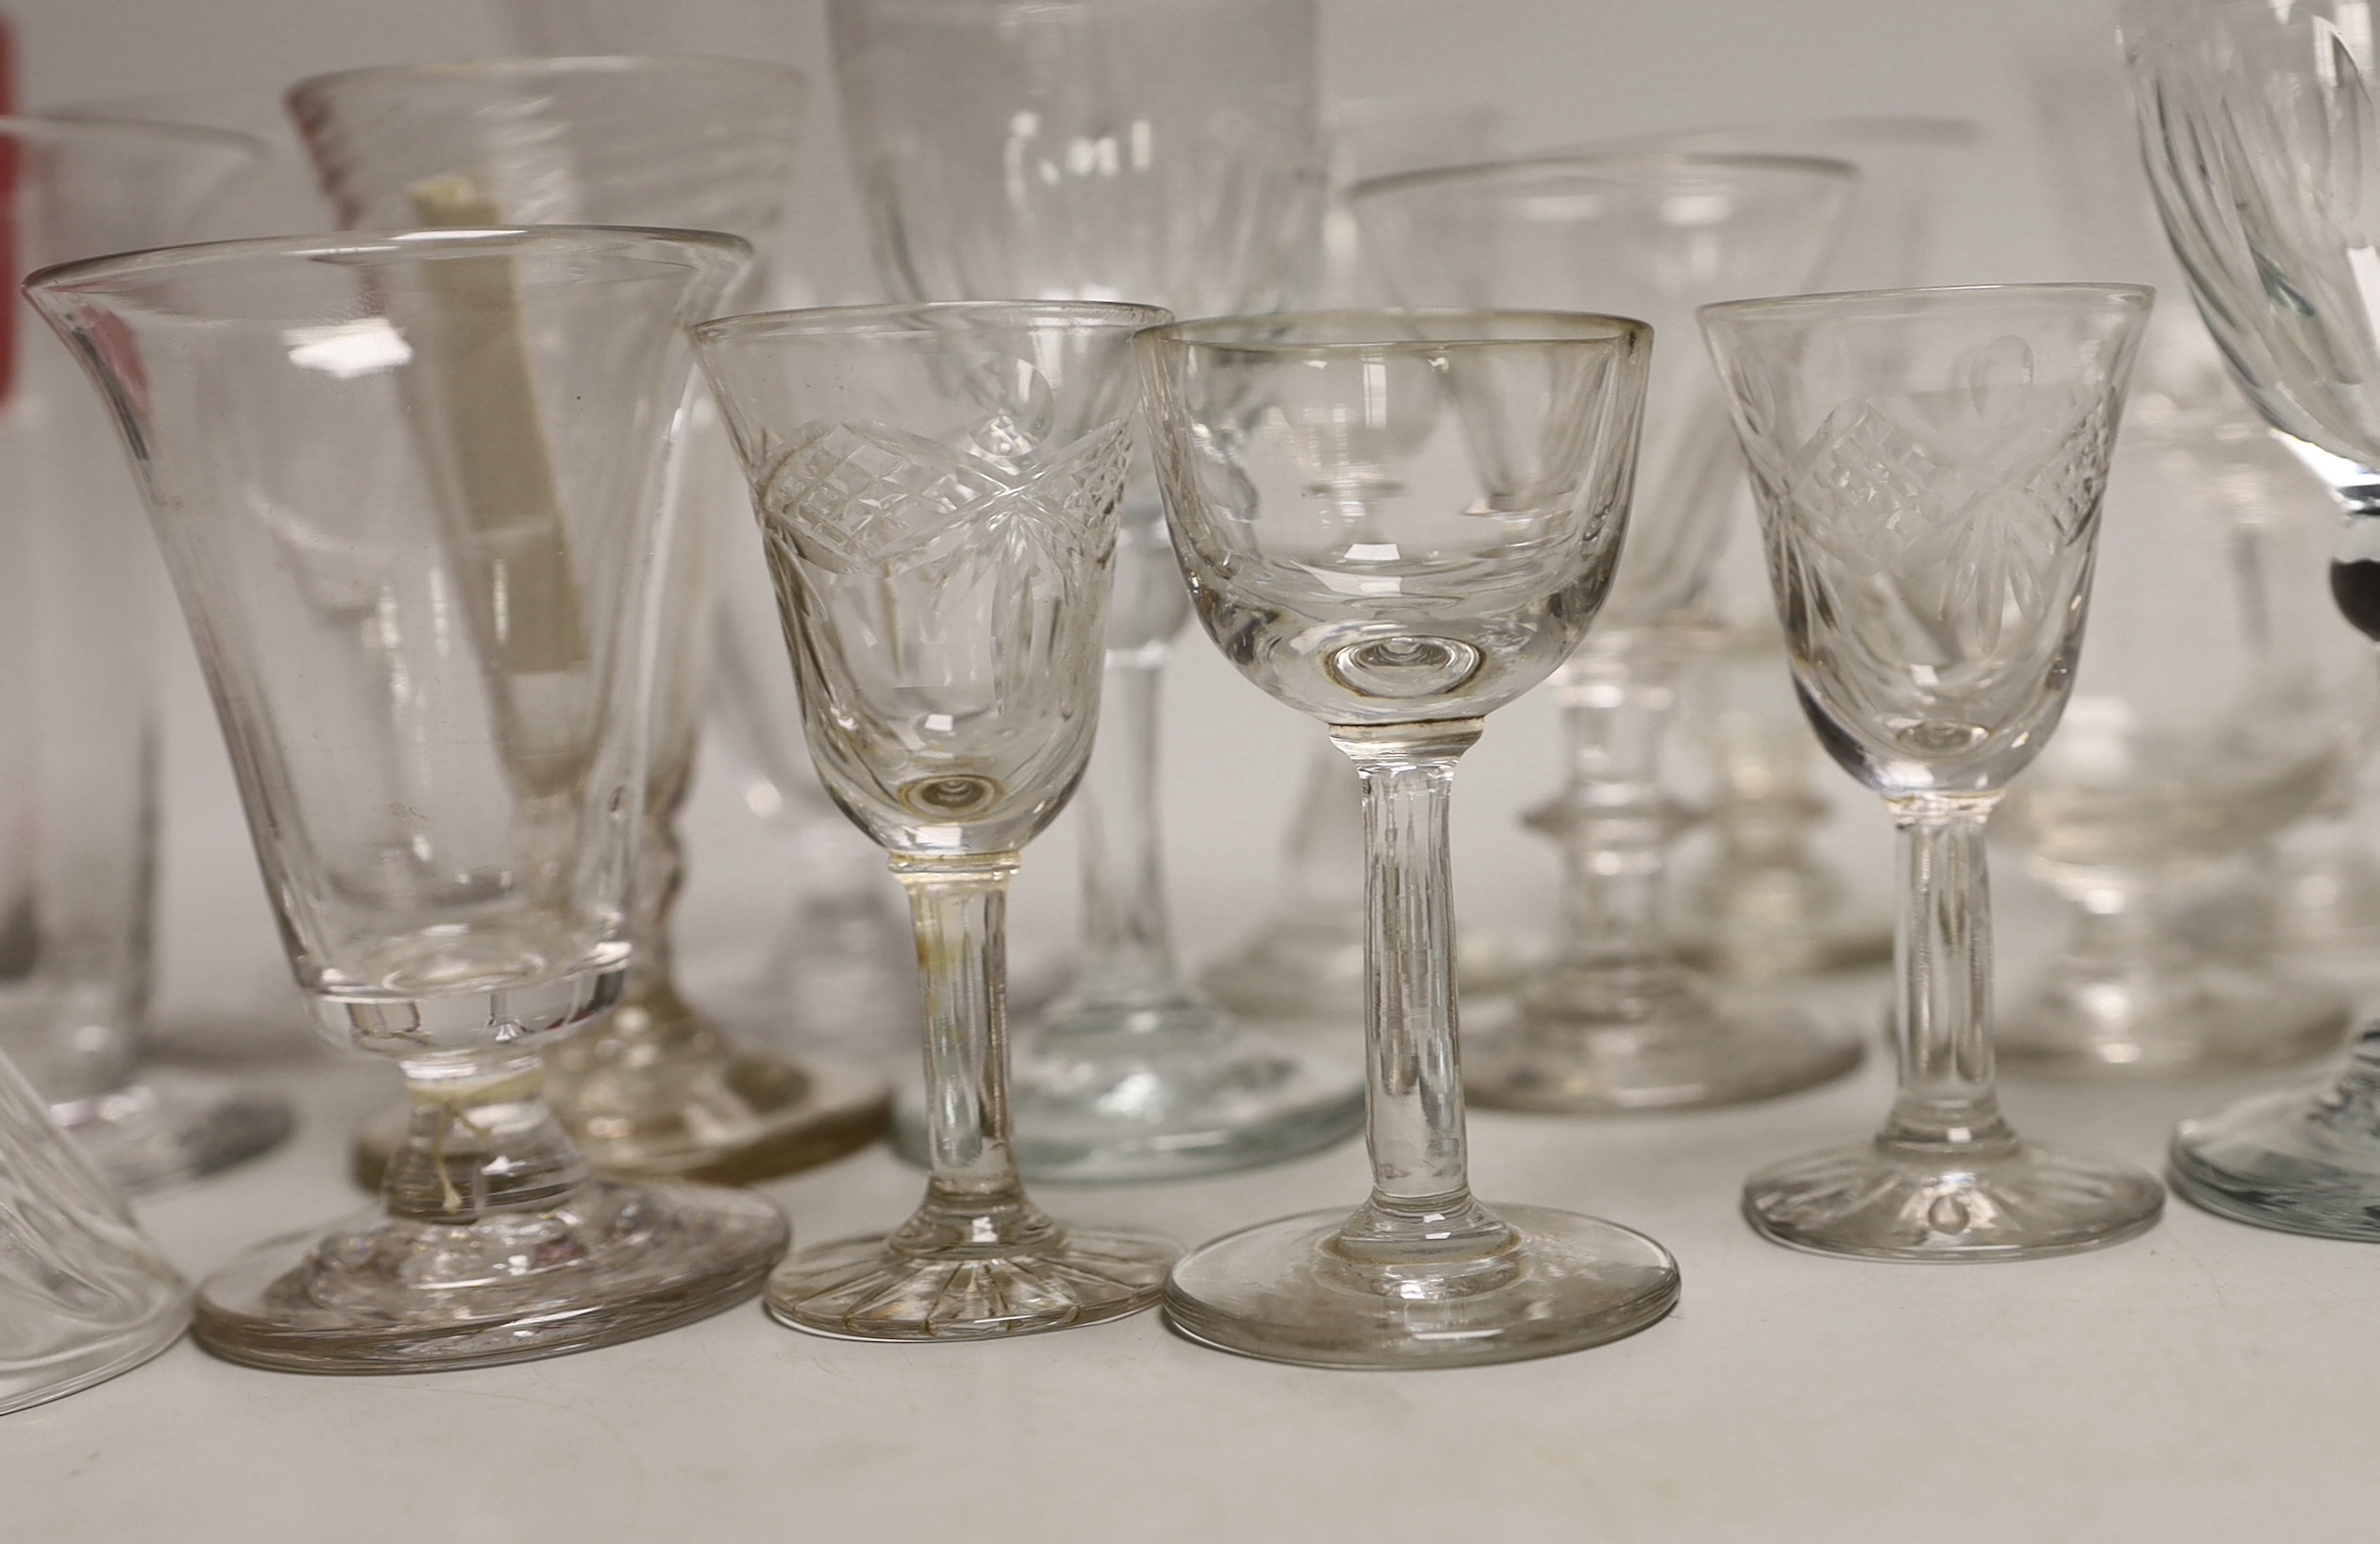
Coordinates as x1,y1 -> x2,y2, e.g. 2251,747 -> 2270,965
1876,792 -> 2016,1151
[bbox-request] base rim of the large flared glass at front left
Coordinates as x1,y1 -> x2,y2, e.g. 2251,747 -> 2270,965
191,1180 -> 790,1375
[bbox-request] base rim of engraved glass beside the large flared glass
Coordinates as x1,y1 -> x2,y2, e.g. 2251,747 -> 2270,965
762,1223 -> 1180,1344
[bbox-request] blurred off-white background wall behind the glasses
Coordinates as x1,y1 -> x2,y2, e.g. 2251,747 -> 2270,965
9,0 -> 2189,1037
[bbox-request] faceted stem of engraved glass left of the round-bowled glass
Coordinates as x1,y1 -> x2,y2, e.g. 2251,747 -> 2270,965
890,851 -> 1059,1256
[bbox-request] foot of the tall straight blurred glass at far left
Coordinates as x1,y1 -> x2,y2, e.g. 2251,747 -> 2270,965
50,1066 -> 297,1192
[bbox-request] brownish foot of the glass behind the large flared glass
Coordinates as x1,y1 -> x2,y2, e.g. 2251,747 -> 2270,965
347,1047 -> 890,1192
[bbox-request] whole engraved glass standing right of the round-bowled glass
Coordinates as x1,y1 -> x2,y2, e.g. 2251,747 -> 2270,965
1702,285 -> 2166,1261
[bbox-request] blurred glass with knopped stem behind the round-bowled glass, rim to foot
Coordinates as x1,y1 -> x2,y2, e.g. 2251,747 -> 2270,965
1347,155 -> 1861,1114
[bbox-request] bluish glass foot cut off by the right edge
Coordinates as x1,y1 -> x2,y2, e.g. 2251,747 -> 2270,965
2169,1066 -> 2380,1242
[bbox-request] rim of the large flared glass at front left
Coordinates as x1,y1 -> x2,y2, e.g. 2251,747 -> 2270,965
24,226 -> 752,295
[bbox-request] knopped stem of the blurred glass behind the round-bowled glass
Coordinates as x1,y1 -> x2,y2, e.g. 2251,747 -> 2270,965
1544,643 -> 1680,978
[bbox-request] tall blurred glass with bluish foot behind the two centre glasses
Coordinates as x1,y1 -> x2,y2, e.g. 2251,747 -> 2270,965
828,0 -> 1364,1180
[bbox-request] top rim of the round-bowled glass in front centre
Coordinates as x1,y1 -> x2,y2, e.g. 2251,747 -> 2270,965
1140,310 -> 1652,357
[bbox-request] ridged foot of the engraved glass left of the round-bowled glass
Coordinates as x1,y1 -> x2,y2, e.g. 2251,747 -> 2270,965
768,1225 -> 1180,1339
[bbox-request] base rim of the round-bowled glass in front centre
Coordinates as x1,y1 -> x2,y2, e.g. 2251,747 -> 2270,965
1164,1206 -> 1682,1373
